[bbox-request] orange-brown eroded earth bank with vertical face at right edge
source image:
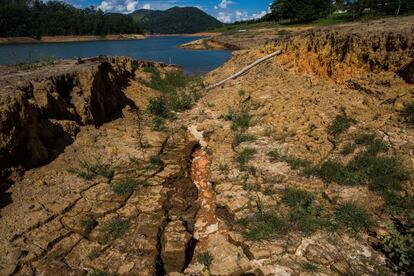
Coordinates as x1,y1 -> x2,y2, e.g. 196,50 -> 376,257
269,17 -> 414,82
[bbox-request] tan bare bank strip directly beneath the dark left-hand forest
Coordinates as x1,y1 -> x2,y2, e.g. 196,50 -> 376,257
0,34 -> 146,45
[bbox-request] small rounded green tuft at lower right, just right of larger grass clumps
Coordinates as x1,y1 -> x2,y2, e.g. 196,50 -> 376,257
335,202 -> 374,232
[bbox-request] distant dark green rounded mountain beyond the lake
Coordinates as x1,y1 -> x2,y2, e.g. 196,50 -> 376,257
130,7 -> 223,34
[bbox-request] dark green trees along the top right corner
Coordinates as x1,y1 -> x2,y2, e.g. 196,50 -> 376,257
264,0 -> 414,23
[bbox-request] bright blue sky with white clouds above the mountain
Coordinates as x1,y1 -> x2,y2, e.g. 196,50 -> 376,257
59,0 -> 272,23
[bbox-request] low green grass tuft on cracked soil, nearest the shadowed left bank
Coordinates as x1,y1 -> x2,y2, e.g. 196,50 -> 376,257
68,158 -> 114,180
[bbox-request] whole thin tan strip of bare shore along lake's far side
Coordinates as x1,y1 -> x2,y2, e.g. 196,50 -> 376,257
0,32 -> 220,45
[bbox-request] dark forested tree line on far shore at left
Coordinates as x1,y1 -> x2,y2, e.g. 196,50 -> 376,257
0,0 -> 141,39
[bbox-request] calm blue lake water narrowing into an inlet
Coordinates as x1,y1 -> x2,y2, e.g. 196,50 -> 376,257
0,36 -> 231,74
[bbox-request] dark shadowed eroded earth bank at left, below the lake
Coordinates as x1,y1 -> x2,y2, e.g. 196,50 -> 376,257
0,58 -> 140,174
